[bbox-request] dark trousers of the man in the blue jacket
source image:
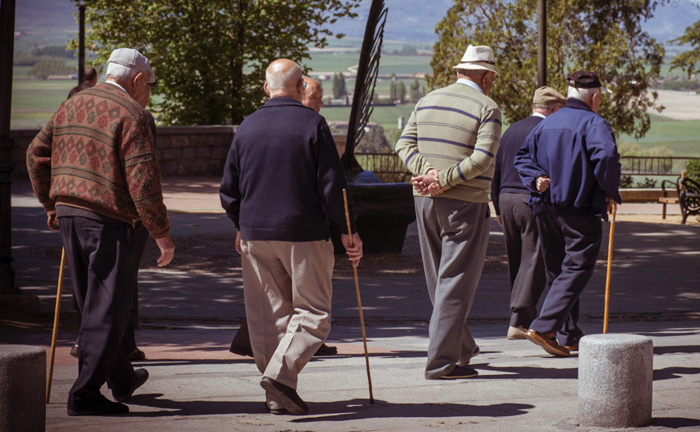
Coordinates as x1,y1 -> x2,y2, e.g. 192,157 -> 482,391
530,203 -> 603,346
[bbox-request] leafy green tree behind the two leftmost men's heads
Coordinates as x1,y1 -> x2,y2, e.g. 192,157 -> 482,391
71,0 -> 360,125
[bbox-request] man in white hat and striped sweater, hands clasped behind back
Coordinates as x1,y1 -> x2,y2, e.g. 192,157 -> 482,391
396,45 -> 501,379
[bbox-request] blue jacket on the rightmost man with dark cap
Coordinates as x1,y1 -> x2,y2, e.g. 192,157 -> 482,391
515,99 -> 621,219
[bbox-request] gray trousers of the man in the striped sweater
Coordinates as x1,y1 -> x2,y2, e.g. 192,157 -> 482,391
414,197 -> 490,379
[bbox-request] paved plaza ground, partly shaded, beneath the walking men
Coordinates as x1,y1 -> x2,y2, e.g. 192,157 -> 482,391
0,178 -> 700,432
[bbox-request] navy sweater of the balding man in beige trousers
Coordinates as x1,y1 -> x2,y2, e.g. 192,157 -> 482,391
219,97 -> 356,242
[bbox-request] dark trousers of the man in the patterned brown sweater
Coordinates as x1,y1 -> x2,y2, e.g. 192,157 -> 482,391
59,216 -> 138,407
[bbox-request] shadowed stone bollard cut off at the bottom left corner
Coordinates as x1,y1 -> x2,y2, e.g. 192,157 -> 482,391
0,345 -> 46,432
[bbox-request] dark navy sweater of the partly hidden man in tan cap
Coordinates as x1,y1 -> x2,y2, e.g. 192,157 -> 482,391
491,115 -> 544,215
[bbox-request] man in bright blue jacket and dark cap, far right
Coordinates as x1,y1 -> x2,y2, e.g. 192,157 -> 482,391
515,71 -> 621,357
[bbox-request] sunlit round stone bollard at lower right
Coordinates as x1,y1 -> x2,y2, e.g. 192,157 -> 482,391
578,334 -> 654,428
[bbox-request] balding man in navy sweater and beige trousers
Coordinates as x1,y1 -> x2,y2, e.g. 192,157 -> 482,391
220,59 -> 362,414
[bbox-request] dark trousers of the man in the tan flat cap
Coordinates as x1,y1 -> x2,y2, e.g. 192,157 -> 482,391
499,193 -> 546,328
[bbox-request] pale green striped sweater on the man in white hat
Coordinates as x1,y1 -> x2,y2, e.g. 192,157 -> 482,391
396,83 -> 501,203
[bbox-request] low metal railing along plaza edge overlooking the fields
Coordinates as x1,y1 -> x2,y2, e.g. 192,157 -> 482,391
355,153 -> 700,183
